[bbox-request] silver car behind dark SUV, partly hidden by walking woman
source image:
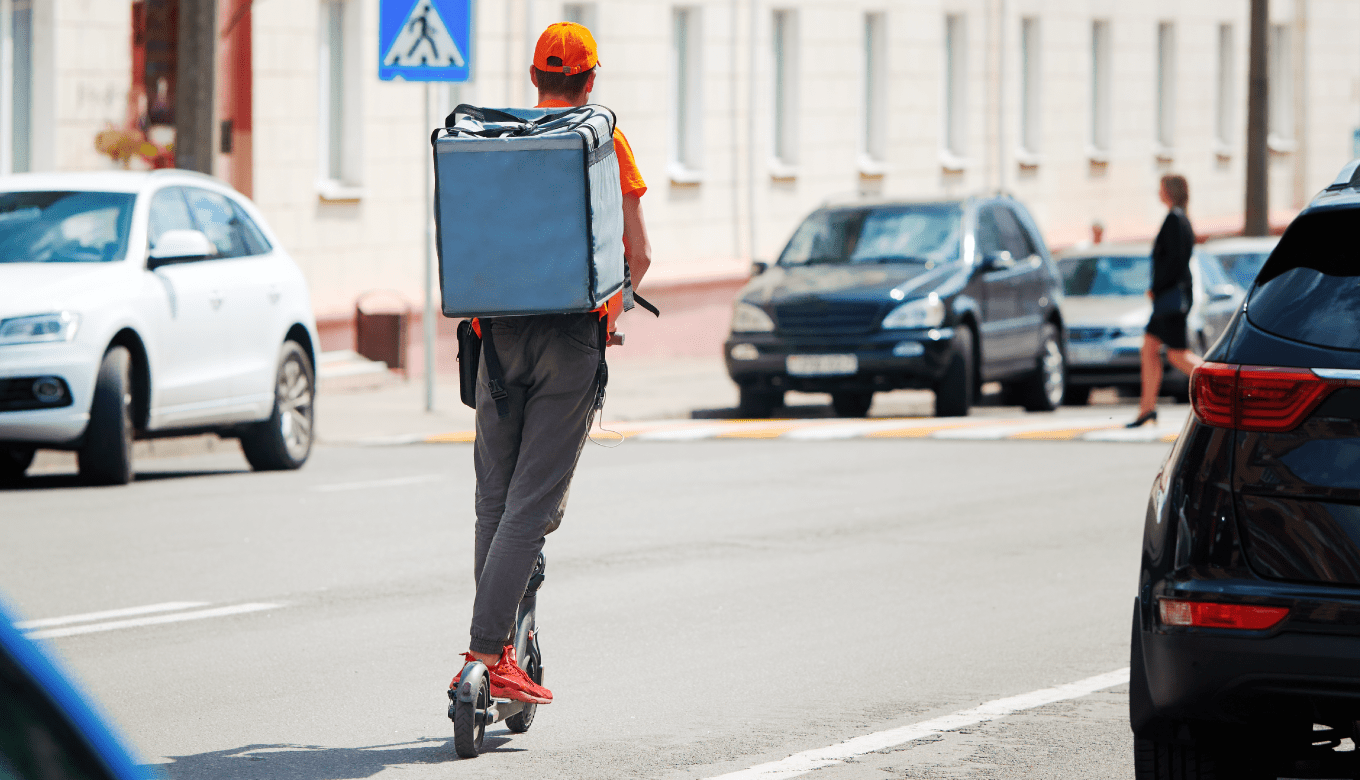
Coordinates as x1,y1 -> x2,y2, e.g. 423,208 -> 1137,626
1058,242 -> 1231,404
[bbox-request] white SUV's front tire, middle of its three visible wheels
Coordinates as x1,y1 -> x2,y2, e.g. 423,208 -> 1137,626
76,347 -> 132,485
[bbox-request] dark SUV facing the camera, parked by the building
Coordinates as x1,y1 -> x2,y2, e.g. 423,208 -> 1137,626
725,197 -> 1066,417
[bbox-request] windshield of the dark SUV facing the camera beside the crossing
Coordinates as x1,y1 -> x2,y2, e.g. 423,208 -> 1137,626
779,204 -> 963,265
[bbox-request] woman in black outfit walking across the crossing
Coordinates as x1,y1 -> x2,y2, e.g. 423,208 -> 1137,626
1129,175 -> 1204,428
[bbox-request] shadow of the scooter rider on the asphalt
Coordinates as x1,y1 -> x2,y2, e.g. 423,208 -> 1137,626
156,734 -> 520,780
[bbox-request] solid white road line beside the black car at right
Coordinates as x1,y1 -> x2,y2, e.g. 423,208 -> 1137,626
710,669 -> 1129,780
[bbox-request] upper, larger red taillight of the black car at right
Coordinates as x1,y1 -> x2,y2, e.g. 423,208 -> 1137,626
1190,363 -> 1350,432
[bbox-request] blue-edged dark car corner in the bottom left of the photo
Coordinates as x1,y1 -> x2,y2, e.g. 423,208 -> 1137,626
0,607 -> 151,780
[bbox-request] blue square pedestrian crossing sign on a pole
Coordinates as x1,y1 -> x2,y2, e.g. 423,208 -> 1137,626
378,0 -> 472,82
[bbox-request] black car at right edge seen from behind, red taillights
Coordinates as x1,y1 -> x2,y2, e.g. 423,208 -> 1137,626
1129,160 -> 1360,780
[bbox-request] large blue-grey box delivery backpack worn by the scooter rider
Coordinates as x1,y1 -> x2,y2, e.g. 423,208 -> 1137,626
430,105 -> 657,417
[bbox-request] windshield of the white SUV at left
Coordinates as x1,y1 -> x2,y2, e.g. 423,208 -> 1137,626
0,192 -> 136,262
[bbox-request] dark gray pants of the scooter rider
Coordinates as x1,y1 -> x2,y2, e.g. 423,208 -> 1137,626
471,314 -> 600,654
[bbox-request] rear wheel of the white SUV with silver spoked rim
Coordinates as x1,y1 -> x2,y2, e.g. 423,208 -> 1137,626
241,341 -> 317,472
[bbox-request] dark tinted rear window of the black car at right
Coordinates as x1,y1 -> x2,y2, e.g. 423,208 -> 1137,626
1247,208 -> 1360,349
